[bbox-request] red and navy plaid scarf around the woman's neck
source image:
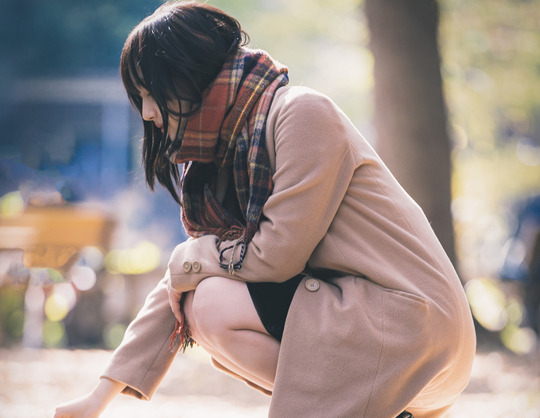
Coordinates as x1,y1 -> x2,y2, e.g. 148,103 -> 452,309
167,48 -> 289,274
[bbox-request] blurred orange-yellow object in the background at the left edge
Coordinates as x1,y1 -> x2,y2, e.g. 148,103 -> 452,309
0,205 -> 114,270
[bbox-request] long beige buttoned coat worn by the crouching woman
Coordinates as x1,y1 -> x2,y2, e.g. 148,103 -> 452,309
102,87 -> 475,418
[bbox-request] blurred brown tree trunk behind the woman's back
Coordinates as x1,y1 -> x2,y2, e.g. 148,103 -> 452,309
365,0 -> 456,265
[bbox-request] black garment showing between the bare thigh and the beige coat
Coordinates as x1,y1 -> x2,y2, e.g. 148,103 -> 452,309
247,274 -> 304,342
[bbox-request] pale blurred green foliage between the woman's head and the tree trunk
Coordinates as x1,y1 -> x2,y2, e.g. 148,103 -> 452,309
210,0 -> 373,125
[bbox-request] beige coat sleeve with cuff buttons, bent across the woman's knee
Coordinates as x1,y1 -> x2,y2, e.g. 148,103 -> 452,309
169,89 -> 358,292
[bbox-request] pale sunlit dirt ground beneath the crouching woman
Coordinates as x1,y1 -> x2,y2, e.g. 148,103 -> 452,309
0,342 -> 540,418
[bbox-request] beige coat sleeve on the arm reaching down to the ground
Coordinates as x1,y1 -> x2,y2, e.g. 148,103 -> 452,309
100,274 -> 179,400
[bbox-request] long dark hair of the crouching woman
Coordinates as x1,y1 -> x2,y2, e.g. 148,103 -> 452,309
120,1 -> 249,203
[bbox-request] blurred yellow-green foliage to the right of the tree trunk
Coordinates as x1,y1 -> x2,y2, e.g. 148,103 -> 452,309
440,0 -> 540,278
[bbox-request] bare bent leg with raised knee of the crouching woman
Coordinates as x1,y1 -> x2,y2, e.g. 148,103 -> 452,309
184,277 -> 280,390
